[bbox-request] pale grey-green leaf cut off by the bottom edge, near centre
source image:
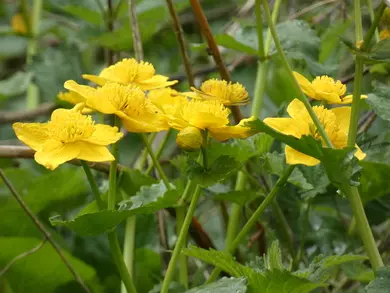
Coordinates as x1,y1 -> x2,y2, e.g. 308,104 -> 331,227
185,278 -> 246,293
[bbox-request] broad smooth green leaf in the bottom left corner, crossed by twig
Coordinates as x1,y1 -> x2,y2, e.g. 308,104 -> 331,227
0,237 -> 96,293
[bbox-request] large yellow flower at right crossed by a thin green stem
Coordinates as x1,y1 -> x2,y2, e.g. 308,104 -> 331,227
264,99 -> 366,166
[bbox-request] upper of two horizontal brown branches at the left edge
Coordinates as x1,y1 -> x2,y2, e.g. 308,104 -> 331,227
0,102 -> 56,124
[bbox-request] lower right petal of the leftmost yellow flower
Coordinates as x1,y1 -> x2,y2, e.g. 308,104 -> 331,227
72,141 -> 115,162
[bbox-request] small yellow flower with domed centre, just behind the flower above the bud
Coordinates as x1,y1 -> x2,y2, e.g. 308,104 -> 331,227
183,79 -> 249,106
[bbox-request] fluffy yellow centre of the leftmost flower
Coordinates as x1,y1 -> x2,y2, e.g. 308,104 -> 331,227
48,110 -> 95,143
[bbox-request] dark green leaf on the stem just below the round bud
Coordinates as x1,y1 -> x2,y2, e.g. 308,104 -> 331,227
187,156 -> 241,187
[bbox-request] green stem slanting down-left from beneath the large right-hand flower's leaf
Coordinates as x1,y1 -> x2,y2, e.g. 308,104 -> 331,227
207,165 -> 295,283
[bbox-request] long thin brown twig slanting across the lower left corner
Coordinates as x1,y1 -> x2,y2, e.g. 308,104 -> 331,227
0,169 -> 90,293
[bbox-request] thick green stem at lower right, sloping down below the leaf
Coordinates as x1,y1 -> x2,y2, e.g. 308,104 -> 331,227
348,186 -> 383,270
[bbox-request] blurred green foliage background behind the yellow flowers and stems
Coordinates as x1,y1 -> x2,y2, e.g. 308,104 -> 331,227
0,0 -> 390,293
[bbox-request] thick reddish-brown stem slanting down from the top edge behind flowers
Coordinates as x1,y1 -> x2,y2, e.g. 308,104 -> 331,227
190,0 -> 243,123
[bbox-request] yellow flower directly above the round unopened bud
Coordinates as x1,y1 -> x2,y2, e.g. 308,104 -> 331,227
168,100 -> 255,147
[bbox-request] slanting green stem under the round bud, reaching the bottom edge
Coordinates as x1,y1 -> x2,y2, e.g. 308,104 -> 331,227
160,185 -> 200,293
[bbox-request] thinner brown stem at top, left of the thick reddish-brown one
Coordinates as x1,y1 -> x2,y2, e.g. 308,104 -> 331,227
166,0 -> 195,86
